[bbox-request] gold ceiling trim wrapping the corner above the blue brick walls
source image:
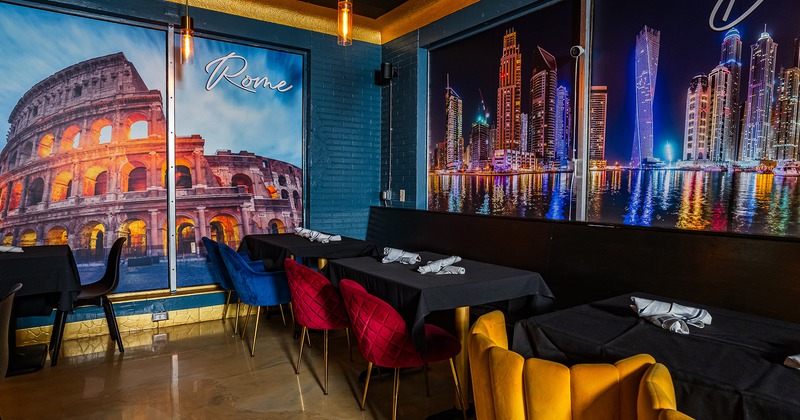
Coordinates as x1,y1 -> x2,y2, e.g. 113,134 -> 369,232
164,0 -> 479,45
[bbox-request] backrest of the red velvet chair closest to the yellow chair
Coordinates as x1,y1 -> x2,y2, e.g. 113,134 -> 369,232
339,279 -> 423,368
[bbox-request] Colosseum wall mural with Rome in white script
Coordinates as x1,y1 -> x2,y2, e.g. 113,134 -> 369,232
0,3 -> 303,292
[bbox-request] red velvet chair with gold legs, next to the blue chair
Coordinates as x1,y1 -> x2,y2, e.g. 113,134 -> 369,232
283,258 -> 353,395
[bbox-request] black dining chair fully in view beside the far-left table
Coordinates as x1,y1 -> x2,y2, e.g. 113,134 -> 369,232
50,238 -> 125,366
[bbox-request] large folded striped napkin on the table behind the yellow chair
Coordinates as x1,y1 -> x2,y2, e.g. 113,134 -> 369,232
631,296 -> 711,334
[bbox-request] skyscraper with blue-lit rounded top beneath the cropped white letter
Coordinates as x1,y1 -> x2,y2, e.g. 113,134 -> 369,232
720,28 -> 742,161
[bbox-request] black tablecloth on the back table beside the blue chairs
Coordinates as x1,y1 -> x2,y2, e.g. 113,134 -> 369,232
239,233 -> 375,268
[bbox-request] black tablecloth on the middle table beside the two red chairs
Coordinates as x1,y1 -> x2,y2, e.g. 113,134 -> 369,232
327,252 -> 555,350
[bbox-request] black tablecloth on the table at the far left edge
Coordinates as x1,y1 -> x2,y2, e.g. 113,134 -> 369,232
0,245 -> 81,317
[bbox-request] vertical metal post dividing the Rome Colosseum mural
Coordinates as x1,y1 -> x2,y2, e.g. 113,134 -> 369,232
166,26 -> 178,293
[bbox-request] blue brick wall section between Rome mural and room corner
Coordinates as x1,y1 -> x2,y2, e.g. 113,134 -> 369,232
307,34 -> 381,238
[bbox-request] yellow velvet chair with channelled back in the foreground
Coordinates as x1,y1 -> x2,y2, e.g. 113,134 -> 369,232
469,311 -> 690,420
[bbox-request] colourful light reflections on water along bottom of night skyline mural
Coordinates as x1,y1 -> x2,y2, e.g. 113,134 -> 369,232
428,170 -> 800,236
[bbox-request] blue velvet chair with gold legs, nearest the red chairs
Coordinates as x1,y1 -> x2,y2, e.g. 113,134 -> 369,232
219,244 -> 294,356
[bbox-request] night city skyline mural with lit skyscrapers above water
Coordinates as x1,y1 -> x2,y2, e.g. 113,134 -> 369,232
428,0 -> 800,236
